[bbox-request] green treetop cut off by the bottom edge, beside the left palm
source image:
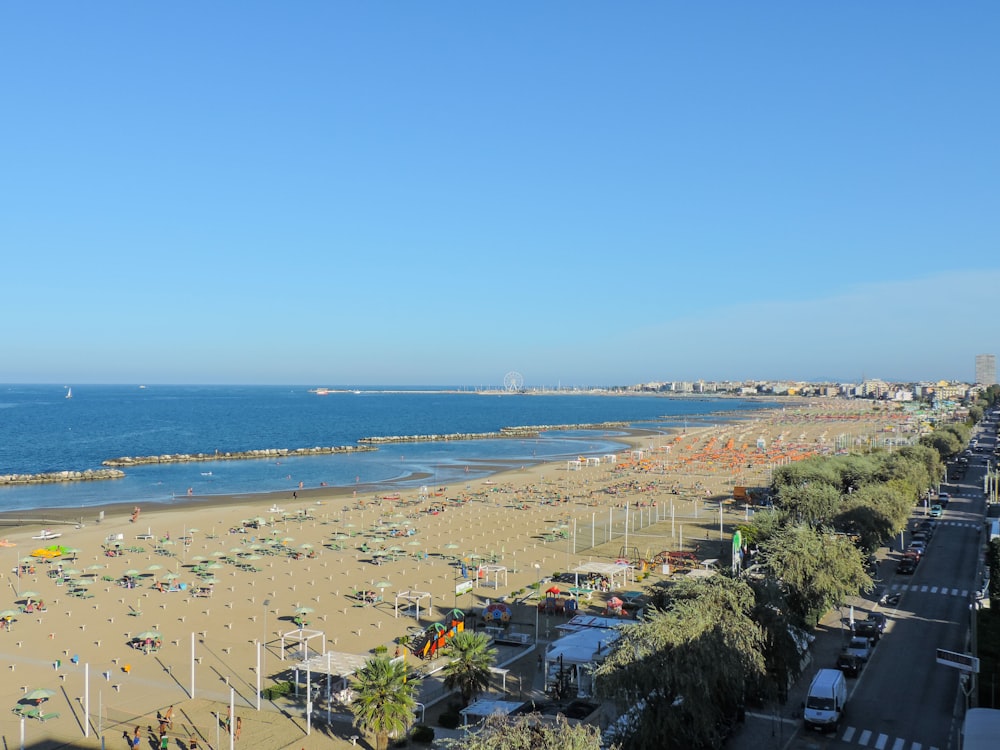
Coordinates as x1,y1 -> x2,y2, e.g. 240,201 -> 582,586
443,714 -> 617,750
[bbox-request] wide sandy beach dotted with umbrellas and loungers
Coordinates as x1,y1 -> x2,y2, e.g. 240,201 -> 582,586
0,400 -> 904,750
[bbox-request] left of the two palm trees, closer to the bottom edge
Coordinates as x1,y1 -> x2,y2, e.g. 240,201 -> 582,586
351,656 -> 420,750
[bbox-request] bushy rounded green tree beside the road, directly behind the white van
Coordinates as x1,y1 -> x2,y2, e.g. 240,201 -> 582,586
763,523 -> 873,628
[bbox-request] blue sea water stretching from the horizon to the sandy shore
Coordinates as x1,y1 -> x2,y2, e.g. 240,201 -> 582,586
0,385 -> 766,511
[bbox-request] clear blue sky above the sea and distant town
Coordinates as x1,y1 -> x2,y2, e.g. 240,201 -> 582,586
0,1 -> 1000,385
